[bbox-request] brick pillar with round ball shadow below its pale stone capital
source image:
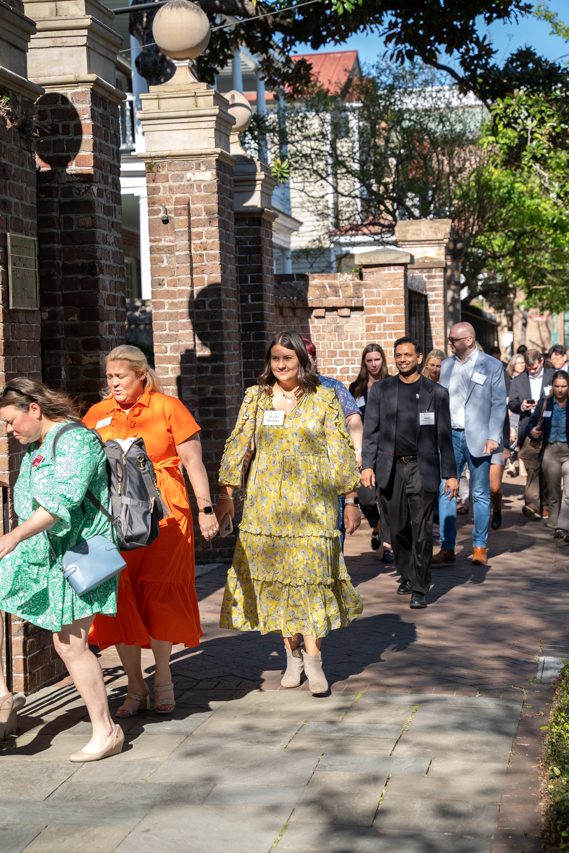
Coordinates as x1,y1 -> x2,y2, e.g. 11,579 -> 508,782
25,0 -> 126,403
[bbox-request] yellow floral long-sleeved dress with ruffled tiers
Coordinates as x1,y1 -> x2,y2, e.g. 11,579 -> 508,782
219,386 -> 363,637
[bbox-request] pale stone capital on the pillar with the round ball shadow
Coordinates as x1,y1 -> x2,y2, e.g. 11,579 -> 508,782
24,0 -> 123,103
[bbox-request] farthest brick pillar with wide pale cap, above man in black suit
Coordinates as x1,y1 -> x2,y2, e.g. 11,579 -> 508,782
395,219 -> 453,352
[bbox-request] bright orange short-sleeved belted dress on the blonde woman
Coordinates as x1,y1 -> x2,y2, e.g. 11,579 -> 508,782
83,391 -> 203,649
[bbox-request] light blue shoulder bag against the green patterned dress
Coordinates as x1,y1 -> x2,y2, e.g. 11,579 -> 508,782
45,422 -> 126,595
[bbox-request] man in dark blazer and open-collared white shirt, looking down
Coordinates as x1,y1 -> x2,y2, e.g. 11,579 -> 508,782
508,349 -> 555,521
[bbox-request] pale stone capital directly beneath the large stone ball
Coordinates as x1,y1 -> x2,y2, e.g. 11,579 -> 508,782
137,82 -> 235,158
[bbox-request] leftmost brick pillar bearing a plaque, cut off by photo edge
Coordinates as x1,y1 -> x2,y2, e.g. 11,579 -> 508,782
0,0 -> 65,693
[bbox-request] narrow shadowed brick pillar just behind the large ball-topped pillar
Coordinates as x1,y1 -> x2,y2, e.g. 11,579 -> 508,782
233,155 -> 277,388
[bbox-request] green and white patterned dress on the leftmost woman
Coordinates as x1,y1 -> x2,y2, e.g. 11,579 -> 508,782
0,424 -> 118,631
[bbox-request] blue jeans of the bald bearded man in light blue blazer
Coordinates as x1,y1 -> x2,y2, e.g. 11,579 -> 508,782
439,429 -> 491,551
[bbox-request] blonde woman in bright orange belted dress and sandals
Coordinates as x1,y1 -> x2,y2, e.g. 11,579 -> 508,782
84,346 -> 219,717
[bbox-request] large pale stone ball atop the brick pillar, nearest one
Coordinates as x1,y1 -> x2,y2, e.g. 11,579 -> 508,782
152,0 -> 211,60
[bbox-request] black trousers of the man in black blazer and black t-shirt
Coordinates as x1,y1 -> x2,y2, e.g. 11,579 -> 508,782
379,459 -> 438,593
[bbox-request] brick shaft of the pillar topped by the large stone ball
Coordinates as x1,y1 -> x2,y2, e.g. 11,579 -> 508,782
147,157 -> 243,560
